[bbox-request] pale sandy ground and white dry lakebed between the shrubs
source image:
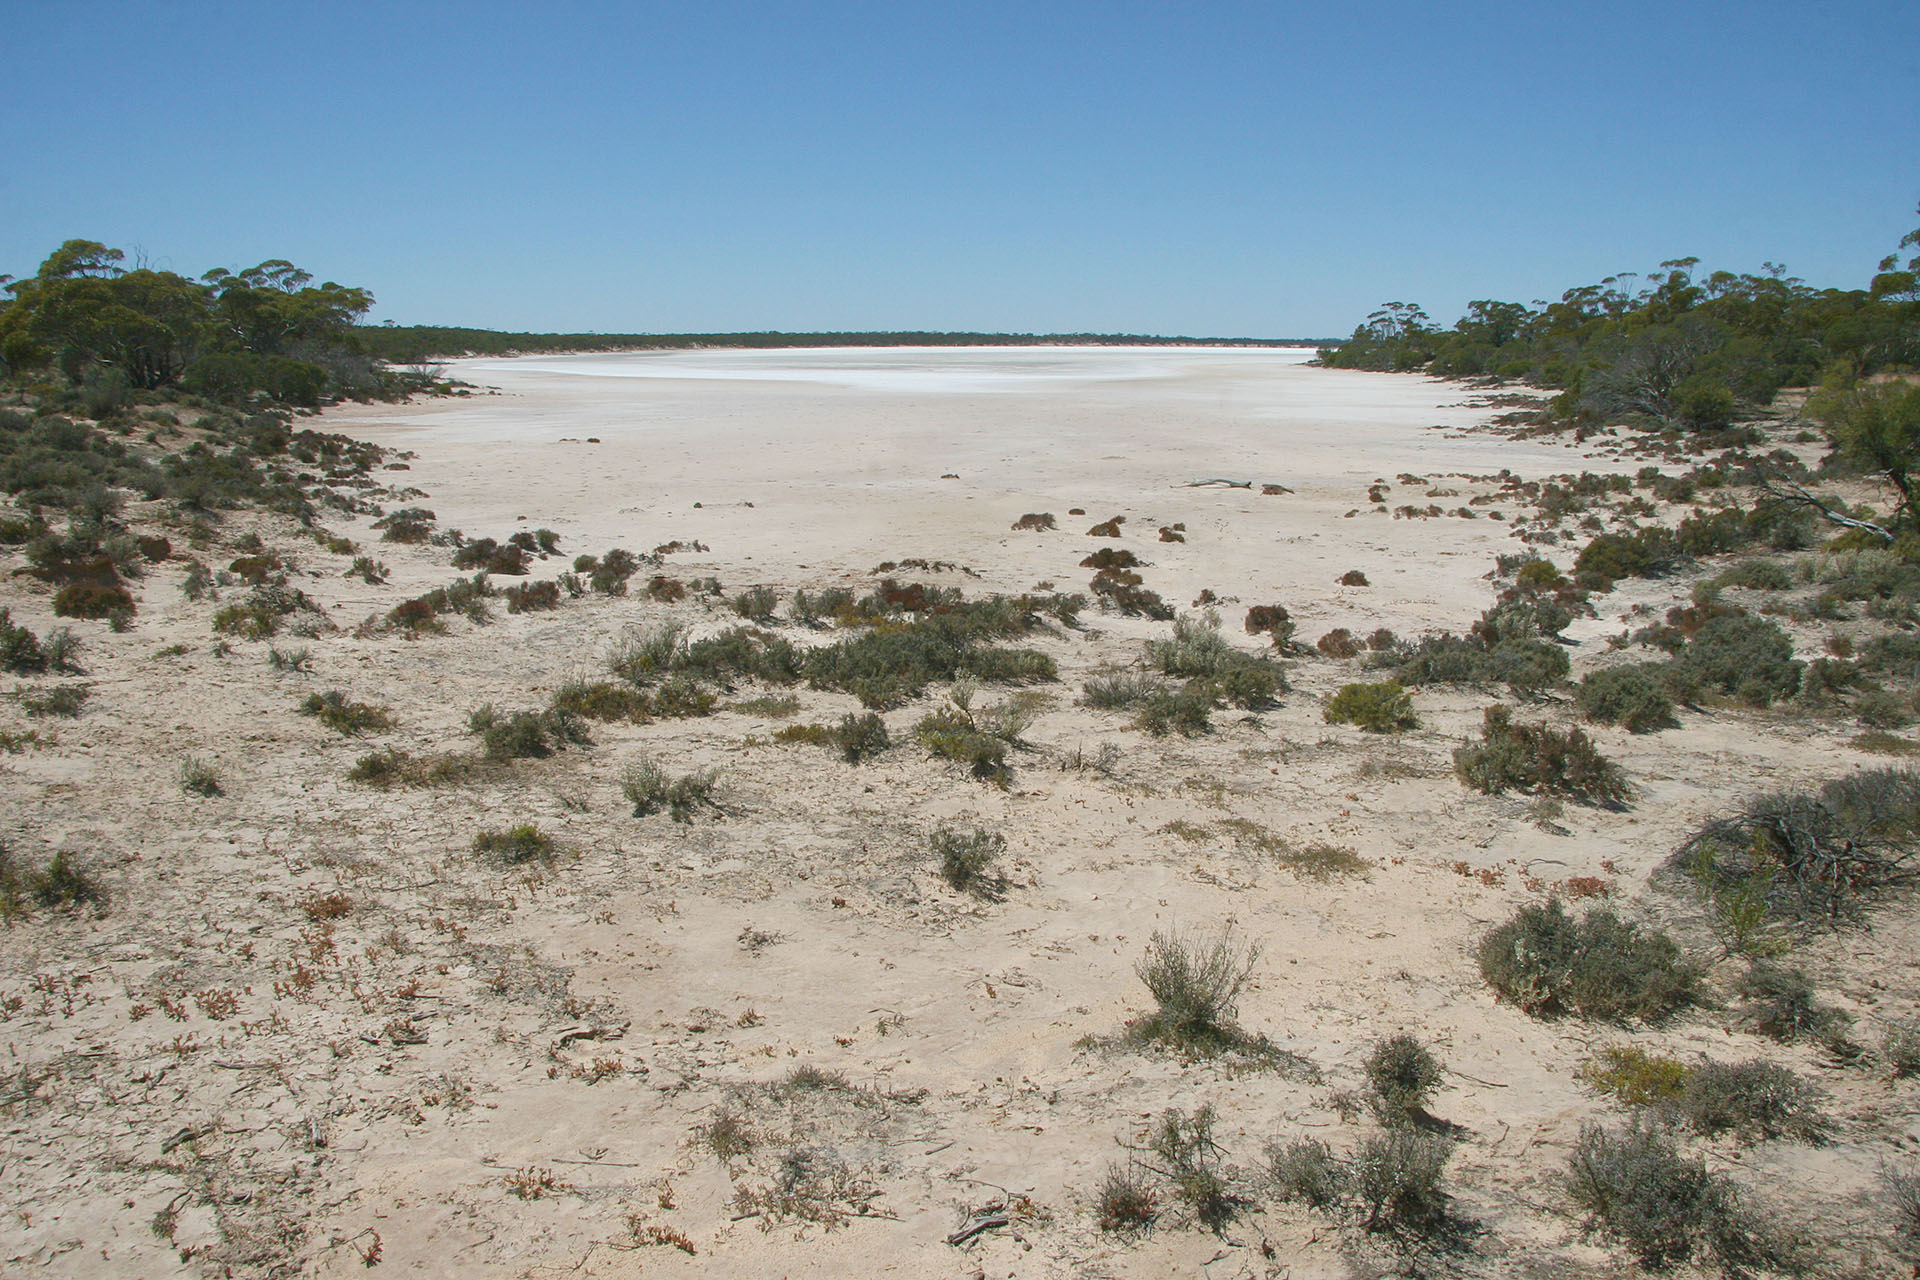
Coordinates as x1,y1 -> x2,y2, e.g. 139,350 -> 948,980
0,351 -> 1916,1278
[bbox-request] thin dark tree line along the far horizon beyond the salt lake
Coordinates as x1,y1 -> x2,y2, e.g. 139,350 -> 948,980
361,324 -> 1319,365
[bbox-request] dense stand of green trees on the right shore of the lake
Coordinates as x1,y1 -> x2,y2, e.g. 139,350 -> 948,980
1321,208 -> 1920,430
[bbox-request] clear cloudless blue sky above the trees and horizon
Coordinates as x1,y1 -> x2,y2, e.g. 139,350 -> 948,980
0,0 -> 1920,336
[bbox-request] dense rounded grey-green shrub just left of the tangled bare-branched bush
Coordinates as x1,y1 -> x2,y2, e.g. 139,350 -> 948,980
1478,898 -> 1699,1023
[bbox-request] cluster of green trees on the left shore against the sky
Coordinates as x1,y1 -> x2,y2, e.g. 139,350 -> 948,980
0,240 -> 408,405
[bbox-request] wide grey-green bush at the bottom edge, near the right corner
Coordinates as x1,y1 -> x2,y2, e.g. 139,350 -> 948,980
1567,1121 -> 1795,1276
